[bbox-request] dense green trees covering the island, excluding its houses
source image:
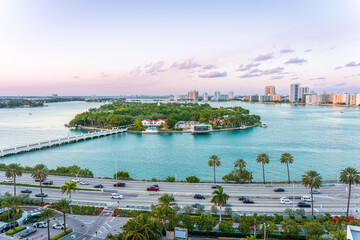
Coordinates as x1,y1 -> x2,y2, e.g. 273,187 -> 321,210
69,101 -> 260,130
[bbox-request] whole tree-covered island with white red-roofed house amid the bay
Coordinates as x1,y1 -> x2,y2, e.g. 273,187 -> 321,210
68,100 -> 260,133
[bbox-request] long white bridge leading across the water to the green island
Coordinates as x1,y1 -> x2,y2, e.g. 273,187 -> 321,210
0,128 -> 127,158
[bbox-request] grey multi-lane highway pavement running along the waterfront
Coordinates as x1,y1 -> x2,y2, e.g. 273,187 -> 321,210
0,172 -> 360,214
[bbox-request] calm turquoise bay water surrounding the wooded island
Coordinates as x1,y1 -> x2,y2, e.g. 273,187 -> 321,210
0,102 -> 360,181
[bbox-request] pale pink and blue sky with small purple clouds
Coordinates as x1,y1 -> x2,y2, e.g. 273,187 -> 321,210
0,0 -> 360,96
